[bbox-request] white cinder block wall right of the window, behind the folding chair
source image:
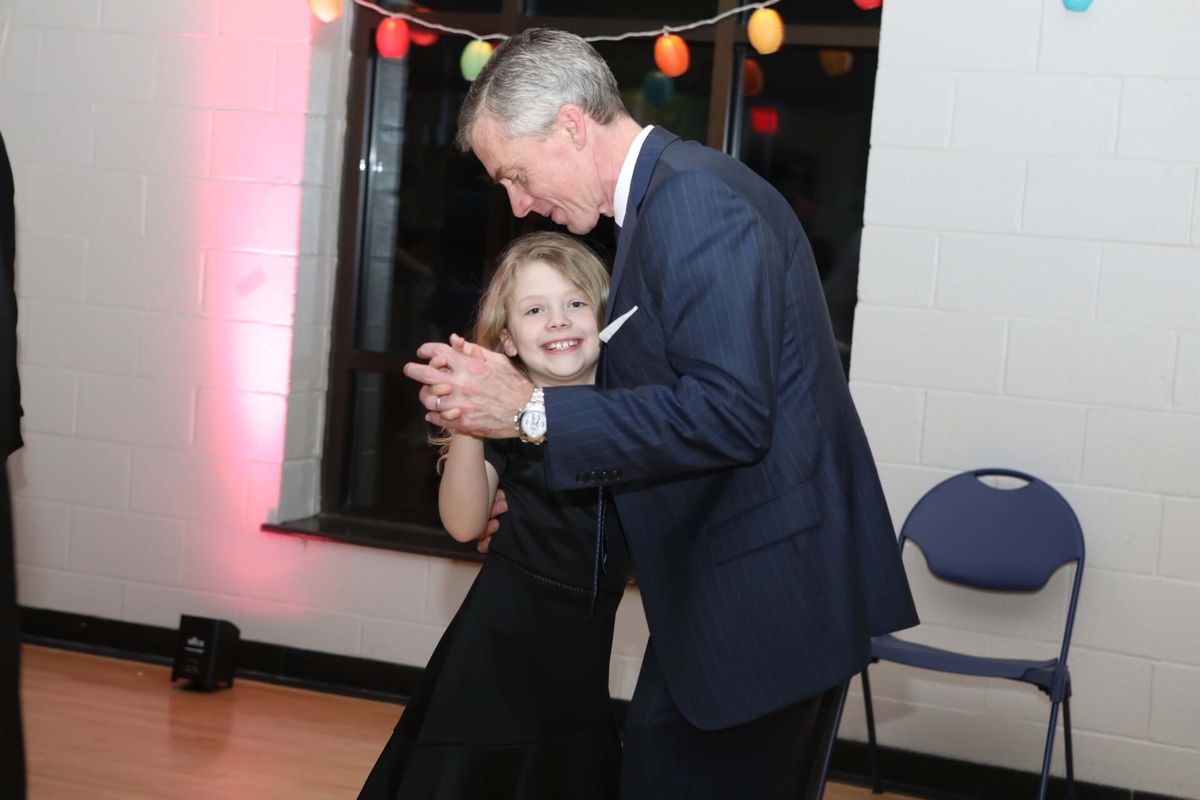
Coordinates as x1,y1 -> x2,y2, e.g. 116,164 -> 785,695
842,0 -> 1200,798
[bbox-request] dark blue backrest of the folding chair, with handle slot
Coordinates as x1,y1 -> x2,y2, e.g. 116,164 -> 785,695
900,468 -> 1084,592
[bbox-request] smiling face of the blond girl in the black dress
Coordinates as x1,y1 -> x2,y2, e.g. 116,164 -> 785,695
500,261 -> 600,386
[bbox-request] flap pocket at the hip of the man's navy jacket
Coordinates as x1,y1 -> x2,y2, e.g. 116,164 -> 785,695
706,482 -> 822,564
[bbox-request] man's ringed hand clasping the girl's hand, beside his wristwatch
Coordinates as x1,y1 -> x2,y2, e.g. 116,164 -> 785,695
404,336 -> 534,439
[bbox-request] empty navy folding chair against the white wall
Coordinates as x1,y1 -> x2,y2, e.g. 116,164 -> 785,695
862,469 -> 1084,799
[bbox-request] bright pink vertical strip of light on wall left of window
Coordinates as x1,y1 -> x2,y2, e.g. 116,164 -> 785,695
190,0 -> 314,599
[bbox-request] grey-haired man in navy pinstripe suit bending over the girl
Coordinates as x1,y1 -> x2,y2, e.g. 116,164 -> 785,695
406,29 -> 917,799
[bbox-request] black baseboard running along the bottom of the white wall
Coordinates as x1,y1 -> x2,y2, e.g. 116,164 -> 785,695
20,608 -> 1182,800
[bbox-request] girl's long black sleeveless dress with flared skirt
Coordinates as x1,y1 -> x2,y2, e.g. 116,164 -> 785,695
359,439 -> 628,800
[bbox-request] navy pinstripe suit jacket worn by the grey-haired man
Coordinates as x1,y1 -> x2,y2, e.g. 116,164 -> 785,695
546,128 -> 917,729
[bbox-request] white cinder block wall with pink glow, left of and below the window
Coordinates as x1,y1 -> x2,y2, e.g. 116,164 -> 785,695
0,0 -> 646,697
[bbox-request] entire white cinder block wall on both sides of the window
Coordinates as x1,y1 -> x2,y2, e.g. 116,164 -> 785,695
0,0 -> 1200,796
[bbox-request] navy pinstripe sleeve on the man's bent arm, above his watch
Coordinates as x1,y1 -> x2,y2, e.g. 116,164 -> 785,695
546,170 -> 786,488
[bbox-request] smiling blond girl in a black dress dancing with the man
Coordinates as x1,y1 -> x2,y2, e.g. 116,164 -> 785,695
359,233 -> 626,800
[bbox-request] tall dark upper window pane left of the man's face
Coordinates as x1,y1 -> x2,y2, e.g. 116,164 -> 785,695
355,37 -> 514,354
